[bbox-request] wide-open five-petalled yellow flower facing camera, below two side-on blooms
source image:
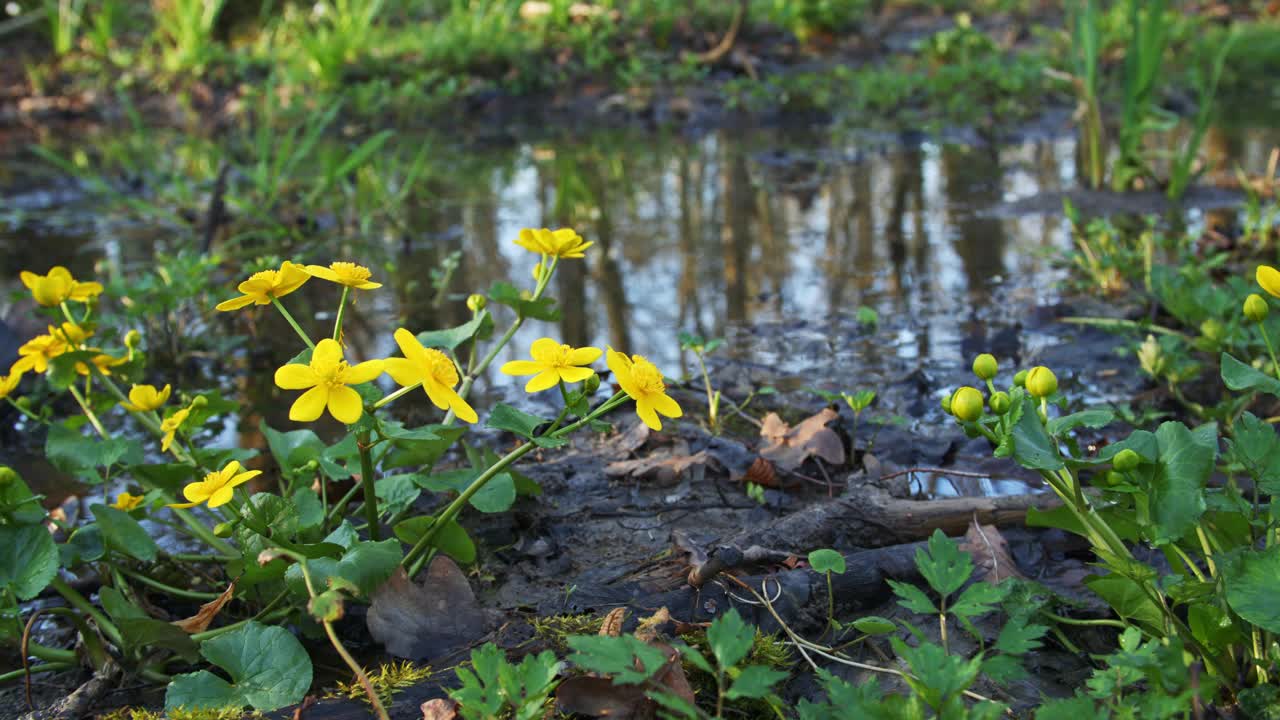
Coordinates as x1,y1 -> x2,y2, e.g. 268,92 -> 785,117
275,338 -> 383,425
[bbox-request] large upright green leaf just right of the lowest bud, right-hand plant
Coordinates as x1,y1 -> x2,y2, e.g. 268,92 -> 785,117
1149,423 -> 1217,544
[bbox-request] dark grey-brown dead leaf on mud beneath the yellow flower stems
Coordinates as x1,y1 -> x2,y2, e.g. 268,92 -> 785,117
365,555 -> 489,660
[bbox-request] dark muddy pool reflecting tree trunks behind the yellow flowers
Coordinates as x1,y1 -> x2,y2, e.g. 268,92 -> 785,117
0,120 -> 1277,492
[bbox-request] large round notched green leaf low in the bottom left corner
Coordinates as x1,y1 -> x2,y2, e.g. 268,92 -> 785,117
164,620 -> 311,712
